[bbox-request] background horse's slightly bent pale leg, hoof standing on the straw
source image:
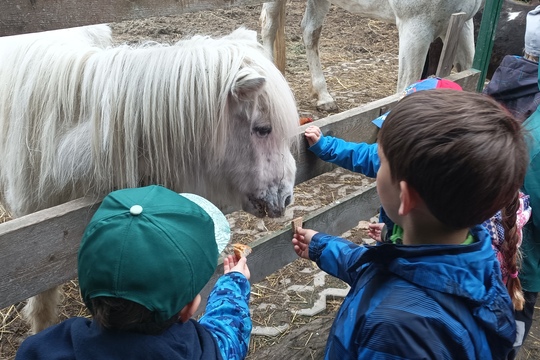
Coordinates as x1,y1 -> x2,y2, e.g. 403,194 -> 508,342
302,0 -> 338,111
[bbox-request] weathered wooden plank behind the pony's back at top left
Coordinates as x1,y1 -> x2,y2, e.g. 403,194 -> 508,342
0,0 -> 272,36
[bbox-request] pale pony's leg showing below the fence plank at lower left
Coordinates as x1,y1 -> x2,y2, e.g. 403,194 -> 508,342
23,286 -> 62,334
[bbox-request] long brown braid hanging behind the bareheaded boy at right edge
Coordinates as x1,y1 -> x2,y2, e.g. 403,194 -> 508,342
499,192 -> 525,311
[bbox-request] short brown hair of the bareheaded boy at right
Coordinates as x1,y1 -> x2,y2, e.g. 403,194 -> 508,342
379,89 -> 528,229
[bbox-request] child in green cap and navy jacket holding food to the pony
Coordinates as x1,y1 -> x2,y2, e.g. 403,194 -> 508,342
16,186 -> 252,360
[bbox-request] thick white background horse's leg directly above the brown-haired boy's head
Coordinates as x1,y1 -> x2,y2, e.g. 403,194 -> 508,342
396,19 -> 434,92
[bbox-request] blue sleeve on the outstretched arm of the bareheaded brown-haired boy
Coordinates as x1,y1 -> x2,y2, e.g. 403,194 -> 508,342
309,233 -> 366,285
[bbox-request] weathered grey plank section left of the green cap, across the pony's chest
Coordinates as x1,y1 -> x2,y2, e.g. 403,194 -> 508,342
0,199 -> 99,308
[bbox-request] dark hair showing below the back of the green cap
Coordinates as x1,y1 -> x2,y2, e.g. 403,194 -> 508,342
90,296 -> 178,335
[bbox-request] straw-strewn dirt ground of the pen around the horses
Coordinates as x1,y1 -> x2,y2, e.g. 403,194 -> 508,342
0,0 -> 540,359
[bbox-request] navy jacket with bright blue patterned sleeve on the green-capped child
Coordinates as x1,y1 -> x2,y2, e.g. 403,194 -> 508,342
15,272 -> 251,360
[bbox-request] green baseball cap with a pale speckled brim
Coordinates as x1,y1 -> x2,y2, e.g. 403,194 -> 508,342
78,185 -> 230,321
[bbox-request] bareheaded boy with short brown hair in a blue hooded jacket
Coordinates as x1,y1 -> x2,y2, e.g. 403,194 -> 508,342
292,89 -> 527,360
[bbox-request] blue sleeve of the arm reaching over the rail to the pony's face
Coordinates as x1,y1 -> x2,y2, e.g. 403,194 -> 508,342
309,136 -> 381,178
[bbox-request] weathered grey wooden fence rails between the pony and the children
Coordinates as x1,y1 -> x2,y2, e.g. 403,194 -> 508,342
0,70 -> 479,308
